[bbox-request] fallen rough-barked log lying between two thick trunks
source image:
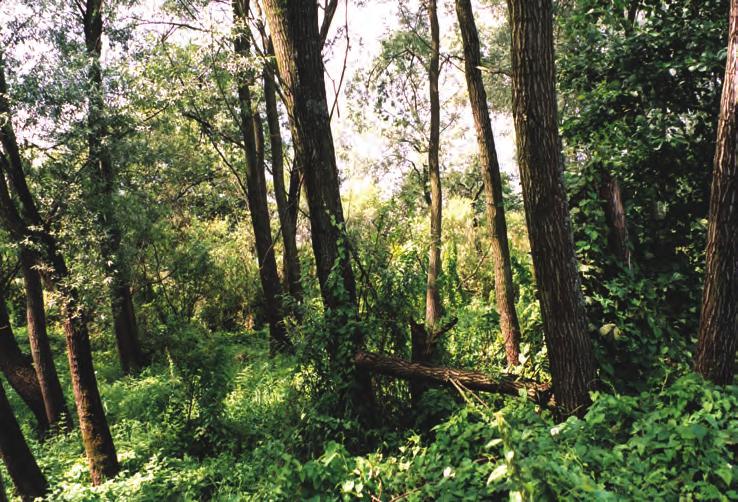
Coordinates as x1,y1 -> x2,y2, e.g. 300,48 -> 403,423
354,352 -> 553,407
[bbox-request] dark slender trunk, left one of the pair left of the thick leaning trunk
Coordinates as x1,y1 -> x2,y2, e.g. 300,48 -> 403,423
233,0 -> 291,353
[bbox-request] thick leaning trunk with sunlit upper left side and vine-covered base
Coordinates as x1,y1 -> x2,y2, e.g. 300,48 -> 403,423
264,0 -> 372,413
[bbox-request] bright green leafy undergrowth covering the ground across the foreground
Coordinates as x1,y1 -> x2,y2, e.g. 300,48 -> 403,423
4,329 -> 738,500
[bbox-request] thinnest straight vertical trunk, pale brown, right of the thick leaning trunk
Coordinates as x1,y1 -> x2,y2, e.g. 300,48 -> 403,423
425,0 -> 443,333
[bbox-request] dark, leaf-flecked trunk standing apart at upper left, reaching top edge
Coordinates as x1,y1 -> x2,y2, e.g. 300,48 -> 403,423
84,0 -> 143,373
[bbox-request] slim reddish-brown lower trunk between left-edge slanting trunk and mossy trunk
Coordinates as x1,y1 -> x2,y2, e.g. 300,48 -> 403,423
20,249 -> 72,430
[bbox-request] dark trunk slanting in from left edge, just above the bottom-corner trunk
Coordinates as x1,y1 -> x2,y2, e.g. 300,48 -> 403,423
0,291 -> 49,437
